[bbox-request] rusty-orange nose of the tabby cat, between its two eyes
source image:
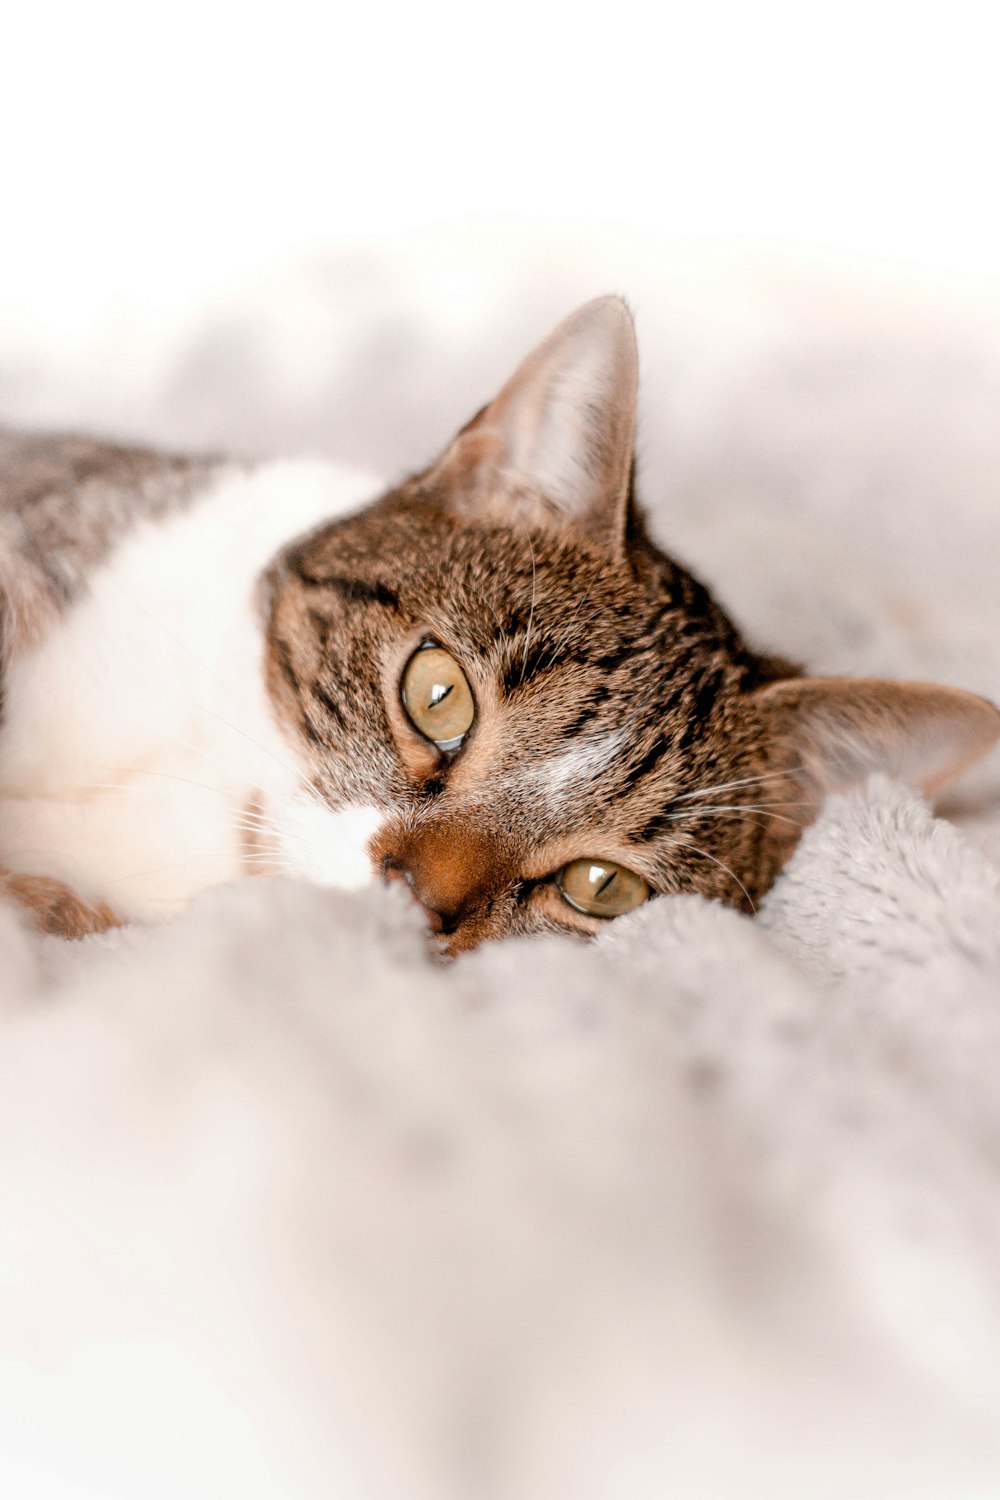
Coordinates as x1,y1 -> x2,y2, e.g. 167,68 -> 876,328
381,822 -> 510,936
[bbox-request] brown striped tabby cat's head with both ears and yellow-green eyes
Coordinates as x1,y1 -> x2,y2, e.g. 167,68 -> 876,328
268,297 -> 1000,953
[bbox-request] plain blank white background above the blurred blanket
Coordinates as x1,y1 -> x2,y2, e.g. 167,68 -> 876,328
0,0 -> 1000,336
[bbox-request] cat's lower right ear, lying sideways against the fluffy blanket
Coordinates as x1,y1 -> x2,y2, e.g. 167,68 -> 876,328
754,677 -> 1000,798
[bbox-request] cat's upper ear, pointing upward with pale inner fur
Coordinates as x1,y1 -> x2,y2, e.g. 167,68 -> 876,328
426,297 -> 639,552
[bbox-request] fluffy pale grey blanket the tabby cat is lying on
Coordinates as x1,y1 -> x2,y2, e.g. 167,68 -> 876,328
0,228 -> 1000,1500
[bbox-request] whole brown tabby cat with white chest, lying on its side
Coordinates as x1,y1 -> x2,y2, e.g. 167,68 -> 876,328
0,297 -> 1000,956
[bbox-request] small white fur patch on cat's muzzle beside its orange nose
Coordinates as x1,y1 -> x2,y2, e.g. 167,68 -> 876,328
270,791 -> 385,891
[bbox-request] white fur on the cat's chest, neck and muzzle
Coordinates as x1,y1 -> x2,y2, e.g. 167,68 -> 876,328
0,464 -> 378,920
